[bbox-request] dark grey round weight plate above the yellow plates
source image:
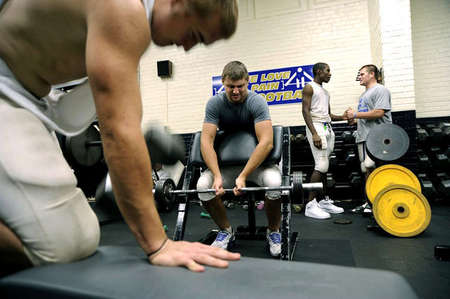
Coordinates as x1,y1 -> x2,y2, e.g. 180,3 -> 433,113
366,124 -> 409,162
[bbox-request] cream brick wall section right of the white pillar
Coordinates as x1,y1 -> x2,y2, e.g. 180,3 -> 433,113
411,0 -> 450,117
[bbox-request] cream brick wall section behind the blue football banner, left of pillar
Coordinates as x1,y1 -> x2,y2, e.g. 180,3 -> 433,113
140,0 -> 371,133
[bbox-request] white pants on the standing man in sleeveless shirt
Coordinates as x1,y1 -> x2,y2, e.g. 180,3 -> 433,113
306,122 -> 335,173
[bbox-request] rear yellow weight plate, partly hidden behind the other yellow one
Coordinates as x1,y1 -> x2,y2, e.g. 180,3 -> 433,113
366,164 -> 422,203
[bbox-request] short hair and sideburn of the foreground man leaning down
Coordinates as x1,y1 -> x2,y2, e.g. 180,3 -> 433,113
188,0 -> 239,38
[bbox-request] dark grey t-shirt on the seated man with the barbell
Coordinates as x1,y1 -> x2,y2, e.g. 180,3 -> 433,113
204,91 -> 270,131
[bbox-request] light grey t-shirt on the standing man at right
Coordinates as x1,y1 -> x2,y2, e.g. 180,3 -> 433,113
356,83 -> 392,143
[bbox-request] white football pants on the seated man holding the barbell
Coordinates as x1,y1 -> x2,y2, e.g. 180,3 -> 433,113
197,165 -> 281,201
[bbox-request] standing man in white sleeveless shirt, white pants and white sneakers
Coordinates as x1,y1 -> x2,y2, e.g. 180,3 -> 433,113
302,62 -> 346,219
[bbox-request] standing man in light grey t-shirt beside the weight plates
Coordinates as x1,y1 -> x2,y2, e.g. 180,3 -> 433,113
346,64 -> 392,212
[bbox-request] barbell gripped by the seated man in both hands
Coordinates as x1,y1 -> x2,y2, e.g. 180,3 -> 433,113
153,171 -> 323,210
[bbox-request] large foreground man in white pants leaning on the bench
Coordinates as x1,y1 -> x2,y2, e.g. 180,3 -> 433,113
0,0 -> 239,275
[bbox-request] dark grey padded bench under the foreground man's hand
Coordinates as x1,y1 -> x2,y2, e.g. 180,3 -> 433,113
0,246 -> 417,299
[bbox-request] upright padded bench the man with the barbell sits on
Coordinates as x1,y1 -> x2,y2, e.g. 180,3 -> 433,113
173,126 -> 298,260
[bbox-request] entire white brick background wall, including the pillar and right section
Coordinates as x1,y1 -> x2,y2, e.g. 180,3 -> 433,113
140,0 -> 450,133
